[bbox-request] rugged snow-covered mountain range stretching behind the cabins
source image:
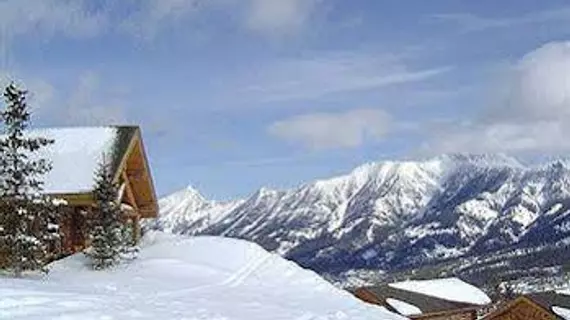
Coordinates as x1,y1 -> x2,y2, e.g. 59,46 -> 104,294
151,155 -> 570,284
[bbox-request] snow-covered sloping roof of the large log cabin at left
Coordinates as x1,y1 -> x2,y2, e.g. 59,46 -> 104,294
12,126 -> 138,194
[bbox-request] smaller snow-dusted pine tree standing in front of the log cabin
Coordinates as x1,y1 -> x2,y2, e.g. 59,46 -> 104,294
87,155 -> 125,269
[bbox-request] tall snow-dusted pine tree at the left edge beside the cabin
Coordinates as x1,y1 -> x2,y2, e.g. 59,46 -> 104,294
0,84 -> 59,276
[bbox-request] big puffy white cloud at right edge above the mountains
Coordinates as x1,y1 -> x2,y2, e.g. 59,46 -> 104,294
423,42 -> 570,154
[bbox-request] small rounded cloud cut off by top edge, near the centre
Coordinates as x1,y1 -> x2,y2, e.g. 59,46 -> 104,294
246,0 -> 321,36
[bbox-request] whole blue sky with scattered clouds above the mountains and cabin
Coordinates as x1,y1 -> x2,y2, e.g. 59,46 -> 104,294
0,0 -> 570,199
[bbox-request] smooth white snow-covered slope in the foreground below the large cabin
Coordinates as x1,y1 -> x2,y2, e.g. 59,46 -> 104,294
0,233 -> 404,320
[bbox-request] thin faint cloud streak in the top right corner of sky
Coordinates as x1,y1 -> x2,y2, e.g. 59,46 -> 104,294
430,7 -> 570,32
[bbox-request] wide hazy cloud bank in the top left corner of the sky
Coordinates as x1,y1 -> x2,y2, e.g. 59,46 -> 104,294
0,0 -> 206,41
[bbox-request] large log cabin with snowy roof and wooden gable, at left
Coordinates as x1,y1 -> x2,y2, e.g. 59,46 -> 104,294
2,126 -> 158,259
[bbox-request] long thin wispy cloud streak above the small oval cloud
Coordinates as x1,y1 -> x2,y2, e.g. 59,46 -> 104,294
240,53 -> 451,101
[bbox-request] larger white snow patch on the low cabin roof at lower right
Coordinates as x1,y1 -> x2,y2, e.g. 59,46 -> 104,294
390,278 -> 491,305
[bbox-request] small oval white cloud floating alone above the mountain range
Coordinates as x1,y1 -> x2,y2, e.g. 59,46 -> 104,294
268,109 -> 391,149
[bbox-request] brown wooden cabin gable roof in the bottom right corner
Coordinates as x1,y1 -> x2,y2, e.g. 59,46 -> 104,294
482,291 -> 570,320
